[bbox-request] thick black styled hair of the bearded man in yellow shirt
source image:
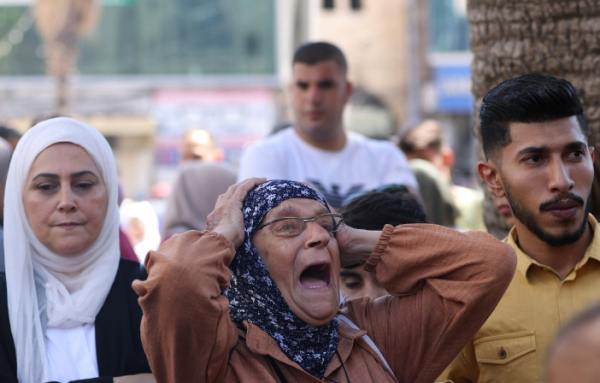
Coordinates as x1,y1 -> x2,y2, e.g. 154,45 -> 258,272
479,74 -> 589,158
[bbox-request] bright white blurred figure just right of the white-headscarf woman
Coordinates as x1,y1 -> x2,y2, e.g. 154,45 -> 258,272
119,199 -> 160,263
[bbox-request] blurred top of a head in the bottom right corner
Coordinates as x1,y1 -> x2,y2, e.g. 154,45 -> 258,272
544,303 -> 600,383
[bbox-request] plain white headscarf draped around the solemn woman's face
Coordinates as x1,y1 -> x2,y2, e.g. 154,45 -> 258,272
4,118 -> 119,383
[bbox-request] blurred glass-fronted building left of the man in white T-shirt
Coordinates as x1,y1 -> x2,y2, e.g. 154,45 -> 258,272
0,0 -> 280,198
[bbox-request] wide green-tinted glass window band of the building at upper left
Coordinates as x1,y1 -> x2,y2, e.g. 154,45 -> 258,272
0,0 -> 277,75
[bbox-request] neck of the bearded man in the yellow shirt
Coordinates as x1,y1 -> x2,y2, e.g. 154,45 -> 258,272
516,217 -> 594,280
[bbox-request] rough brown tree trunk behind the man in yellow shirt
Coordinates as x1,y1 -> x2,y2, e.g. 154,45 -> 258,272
467,0 -> 600,237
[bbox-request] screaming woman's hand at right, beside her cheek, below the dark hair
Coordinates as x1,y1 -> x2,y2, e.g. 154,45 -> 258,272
335,224 -> 381,267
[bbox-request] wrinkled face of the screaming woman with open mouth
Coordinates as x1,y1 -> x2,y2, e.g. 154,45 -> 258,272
252,198 -> 340,326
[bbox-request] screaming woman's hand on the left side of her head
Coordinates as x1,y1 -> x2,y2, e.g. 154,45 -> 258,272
206,178 -> 267,249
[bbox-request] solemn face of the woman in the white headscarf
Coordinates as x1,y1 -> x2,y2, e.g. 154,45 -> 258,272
23,143 -> 108,257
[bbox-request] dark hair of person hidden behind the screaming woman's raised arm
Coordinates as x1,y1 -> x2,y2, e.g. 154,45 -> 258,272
340,192 -> 427,230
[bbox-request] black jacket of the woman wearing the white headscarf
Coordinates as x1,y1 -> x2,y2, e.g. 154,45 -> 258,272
0,259 -> 151,383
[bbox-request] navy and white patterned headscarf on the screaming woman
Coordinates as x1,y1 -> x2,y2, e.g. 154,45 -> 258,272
224,180 -> 339,379
